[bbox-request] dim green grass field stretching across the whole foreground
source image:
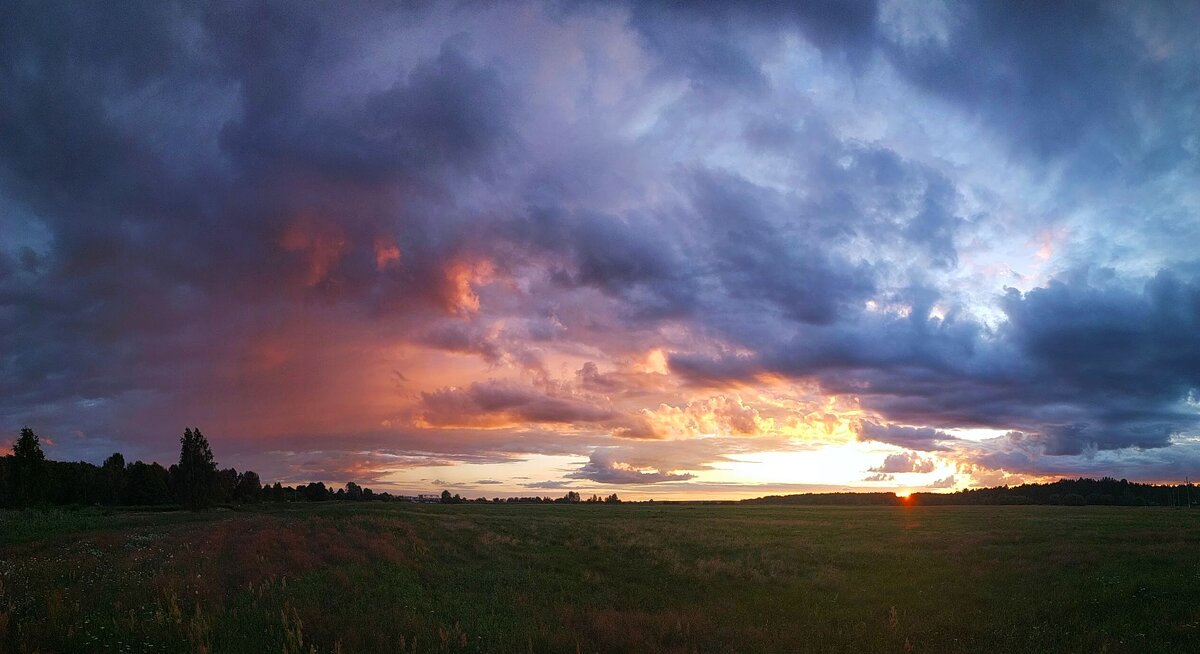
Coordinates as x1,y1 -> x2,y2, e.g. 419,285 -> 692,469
0,503 -> 1200,653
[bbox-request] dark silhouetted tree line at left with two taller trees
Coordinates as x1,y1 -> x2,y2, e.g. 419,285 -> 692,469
0,427 -> 405,510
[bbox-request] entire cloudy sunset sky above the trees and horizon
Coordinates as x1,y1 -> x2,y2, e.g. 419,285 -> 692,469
0,0 -> 1200,499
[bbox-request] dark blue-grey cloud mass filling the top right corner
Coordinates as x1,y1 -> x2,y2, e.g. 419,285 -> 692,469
630,1 -> 1200,182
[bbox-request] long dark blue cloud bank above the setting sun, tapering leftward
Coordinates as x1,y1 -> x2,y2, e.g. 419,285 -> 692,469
671,271 -> 1200,455
